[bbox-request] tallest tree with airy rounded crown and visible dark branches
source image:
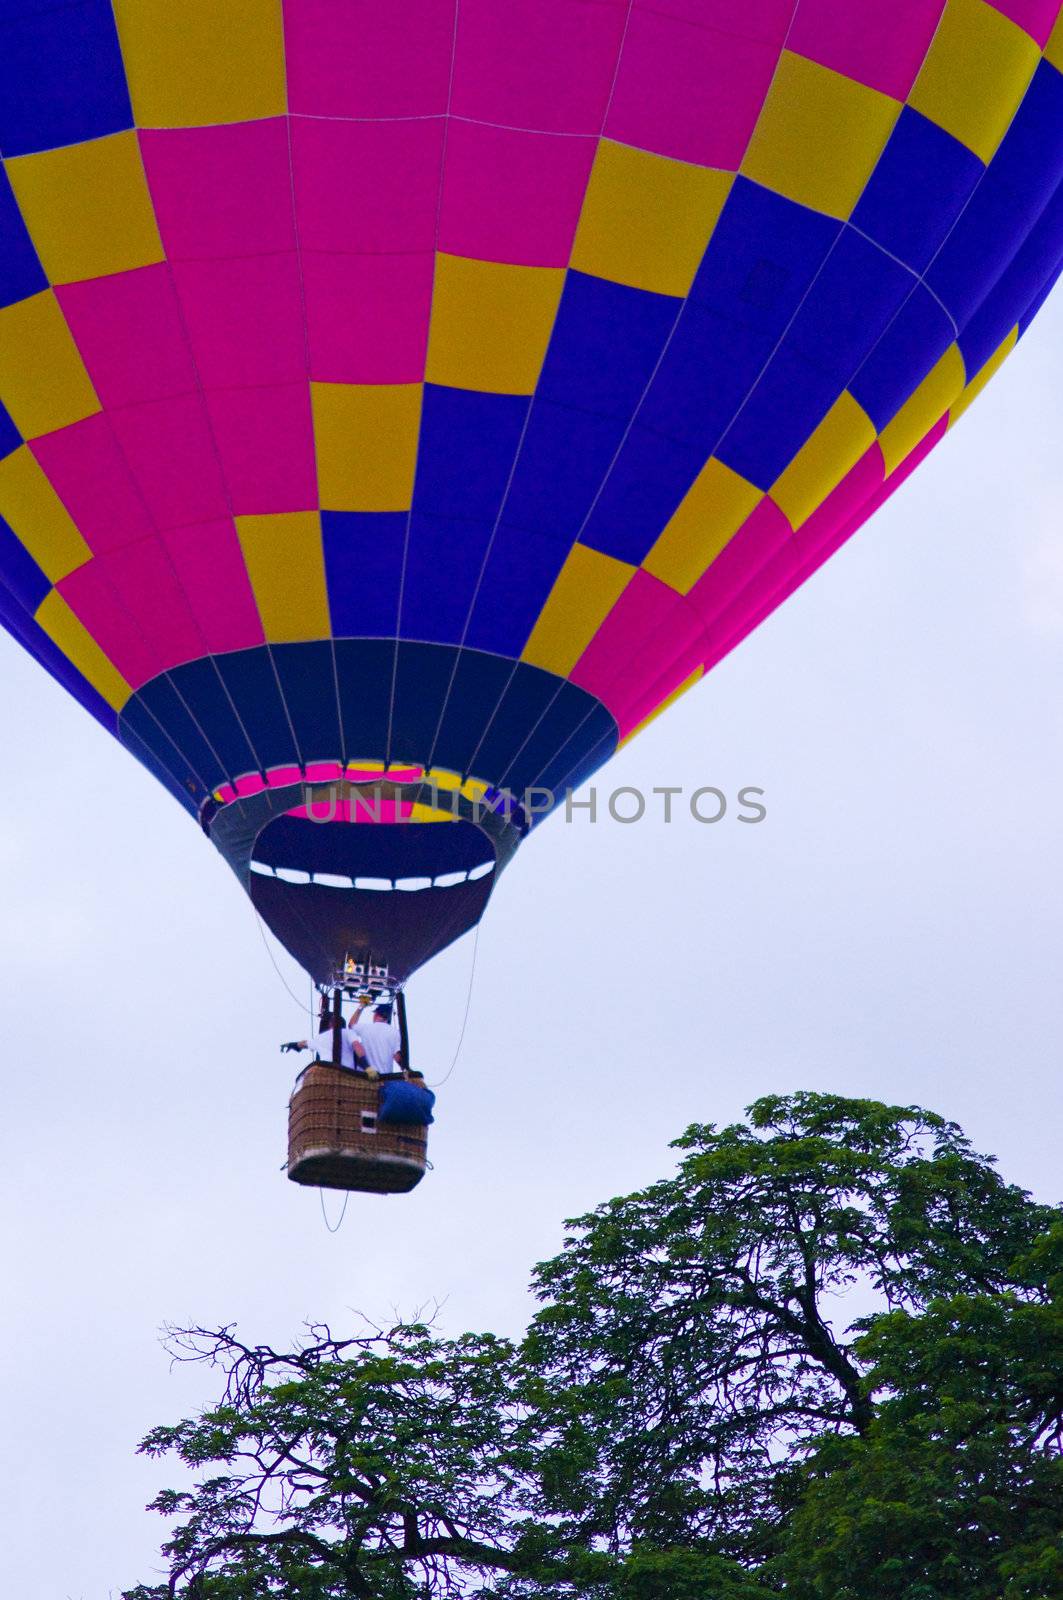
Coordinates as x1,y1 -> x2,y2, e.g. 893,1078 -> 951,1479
525,1094 -> 1055,1563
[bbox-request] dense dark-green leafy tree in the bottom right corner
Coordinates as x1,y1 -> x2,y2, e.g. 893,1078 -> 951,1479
778,1226 -> 1063,1600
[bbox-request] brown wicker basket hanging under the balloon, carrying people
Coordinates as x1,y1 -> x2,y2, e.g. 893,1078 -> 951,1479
288,1062 -> 427,1195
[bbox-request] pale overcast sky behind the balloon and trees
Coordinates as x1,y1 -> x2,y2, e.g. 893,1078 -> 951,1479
0,294 -> 1063,1600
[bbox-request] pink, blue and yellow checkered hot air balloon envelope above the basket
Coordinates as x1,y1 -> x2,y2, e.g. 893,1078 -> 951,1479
0,0 -> 1063,1184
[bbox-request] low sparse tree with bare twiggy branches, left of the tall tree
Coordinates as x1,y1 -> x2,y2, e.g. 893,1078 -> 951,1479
130,1323 -> 541,1600
